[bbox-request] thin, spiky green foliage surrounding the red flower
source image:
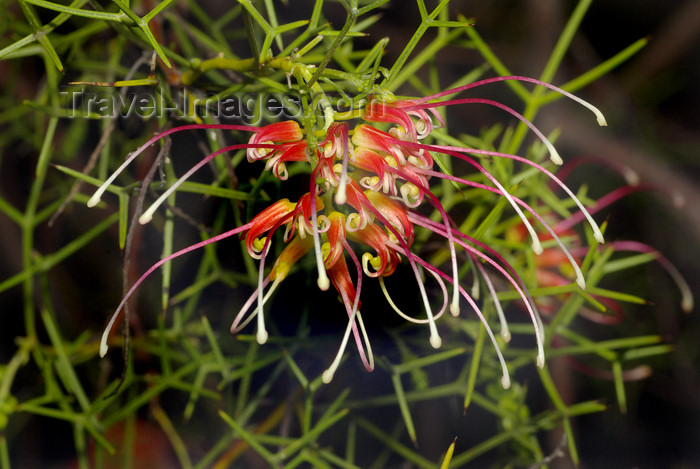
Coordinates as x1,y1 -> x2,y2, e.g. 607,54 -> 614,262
0,0 -> 688,468
